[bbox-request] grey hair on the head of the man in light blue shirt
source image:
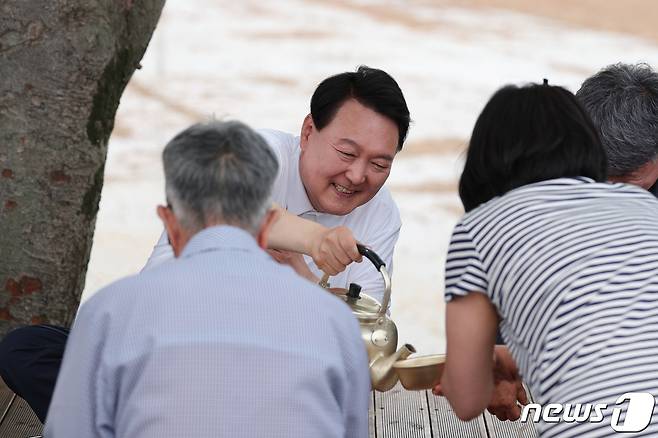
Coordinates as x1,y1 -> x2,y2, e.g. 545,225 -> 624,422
162,121 -> 278,241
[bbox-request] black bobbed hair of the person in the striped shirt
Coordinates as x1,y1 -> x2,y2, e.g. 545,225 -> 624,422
459,84 -> 607,211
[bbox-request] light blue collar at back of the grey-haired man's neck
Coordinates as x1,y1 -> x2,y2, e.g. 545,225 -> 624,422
181,225 -> 261,258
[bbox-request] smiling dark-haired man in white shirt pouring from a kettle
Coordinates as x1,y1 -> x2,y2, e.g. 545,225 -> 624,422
145,66 -> 410,302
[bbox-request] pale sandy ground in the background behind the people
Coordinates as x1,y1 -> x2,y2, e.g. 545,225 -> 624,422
84,0 -> 658,353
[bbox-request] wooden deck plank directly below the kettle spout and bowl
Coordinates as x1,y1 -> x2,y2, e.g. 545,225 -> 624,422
375,383 -> 432,438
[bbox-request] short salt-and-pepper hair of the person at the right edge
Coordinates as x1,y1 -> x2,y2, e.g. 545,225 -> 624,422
576,63 -> 658,176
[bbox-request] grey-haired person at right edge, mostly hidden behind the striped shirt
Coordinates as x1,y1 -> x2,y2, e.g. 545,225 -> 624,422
436,63 -> 658,420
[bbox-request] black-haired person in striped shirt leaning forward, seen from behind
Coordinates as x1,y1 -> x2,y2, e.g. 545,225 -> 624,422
441,83 -> 658,438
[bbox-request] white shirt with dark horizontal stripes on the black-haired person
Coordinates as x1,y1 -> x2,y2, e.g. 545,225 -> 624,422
446,177 -> 658,438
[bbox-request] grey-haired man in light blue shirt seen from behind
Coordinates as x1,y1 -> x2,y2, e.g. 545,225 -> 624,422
46,122 -> 370,438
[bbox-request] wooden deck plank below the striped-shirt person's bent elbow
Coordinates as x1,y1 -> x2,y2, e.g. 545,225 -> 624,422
426,391 -> 488,438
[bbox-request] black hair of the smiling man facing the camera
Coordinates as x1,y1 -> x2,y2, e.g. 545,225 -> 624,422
311,65 -> 410,151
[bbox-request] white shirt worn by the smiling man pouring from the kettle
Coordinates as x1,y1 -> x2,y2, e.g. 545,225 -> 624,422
144,129 -> 402,302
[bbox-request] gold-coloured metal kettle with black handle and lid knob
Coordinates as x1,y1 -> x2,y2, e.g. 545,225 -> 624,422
320,244 -> 416,392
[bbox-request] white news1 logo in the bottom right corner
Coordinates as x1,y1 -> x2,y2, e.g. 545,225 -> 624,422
521,392 -> 656,432
